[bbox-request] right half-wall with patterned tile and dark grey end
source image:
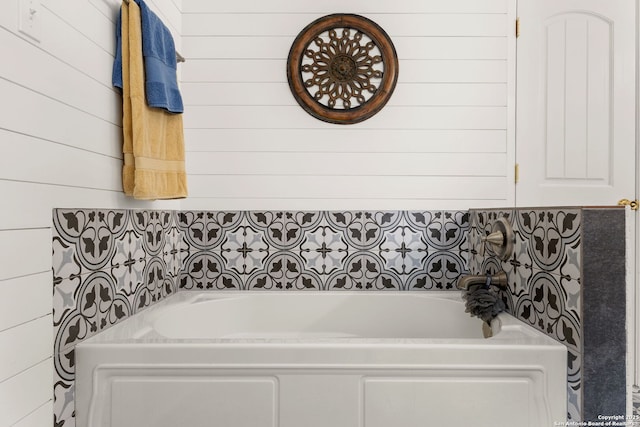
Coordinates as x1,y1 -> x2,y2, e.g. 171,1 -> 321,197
469,208 -> 626,422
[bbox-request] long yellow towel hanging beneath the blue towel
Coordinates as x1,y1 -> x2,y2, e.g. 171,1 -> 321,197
122,1 -> 187,200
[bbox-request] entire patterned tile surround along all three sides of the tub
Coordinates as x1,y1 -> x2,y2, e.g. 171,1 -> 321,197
52,208 -> 624,427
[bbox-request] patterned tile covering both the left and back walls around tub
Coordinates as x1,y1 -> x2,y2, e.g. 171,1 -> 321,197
52,209 -> 469,427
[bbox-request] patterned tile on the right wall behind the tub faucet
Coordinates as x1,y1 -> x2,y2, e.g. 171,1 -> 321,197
468,209 -> 582,421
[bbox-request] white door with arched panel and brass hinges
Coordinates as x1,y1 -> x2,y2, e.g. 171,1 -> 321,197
516,0 -> 636,206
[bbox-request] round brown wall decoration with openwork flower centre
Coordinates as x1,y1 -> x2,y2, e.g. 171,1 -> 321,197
287,14 -> 398,124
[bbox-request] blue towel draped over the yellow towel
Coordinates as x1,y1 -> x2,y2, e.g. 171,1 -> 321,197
113,0 -> 184,113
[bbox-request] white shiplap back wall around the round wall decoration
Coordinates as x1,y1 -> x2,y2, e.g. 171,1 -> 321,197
182,0 -> 515,209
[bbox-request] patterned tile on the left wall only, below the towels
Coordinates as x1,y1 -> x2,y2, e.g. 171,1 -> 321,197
52,209 -> 180,427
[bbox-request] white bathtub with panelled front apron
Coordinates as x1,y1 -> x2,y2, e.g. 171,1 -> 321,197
76,291 -> 567,427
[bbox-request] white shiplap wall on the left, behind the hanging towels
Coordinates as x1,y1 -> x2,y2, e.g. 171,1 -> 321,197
0,0 -> 182,427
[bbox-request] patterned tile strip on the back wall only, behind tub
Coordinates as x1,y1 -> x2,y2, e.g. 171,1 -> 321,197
177,211 -> 469,290
